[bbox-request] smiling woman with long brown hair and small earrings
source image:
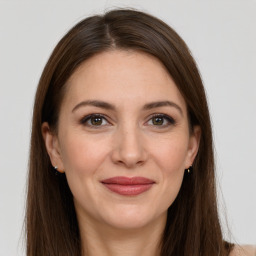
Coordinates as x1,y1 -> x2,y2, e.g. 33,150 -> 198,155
27,10 -> 253,256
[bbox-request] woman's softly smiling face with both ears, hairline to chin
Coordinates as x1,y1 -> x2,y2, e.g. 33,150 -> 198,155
43,50 -> 200,229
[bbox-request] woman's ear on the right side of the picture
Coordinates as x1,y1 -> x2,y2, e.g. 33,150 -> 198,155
186,126 -> 201,168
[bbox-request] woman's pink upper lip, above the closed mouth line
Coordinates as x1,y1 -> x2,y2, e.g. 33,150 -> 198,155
101,176 -> 155,185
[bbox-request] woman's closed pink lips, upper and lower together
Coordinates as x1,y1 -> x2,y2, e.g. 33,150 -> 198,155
101,176 -> 155,196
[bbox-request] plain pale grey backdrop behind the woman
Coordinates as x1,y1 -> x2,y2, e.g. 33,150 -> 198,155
0,0 -> 256,256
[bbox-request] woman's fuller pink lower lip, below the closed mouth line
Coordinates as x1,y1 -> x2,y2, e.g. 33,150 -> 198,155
102,183 -> 153,196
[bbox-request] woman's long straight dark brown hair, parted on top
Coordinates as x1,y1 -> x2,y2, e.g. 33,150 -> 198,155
26,9 -> 232,256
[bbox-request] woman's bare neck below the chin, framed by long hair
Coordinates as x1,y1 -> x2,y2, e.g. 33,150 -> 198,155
78,214 -> 166,256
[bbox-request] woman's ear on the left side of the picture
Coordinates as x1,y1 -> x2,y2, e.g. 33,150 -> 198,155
41,122 -> 64,172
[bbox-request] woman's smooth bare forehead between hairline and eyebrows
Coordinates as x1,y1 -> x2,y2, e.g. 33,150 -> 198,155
62,50 -> 185,108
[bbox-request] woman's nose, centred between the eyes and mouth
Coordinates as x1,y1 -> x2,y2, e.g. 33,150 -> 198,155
111,123 -> 148,168
